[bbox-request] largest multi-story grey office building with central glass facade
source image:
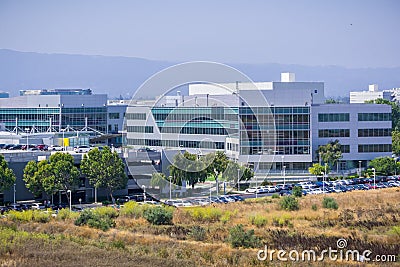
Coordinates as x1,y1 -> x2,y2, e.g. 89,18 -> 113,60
126,74 -> 391,175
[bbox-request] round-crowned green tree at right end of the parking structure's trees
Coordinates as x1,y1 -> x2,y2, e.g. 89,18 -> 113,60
81,147 -> 128,202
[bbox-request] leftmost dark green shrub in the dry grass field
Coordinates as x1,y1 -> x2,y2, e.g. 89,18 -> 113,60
75,209 -> 115,231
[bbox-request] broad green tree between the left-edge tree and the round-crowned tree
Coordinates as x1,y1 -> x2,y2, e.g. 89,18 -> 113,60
23,152 -> 79,203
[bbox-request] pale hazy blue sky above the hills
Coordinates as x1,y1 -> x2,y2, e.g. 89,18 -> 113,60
0,0 -> 400,67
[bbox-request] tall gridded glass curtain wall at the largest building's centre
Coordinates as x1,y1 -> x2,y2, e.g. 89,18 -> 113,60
239,107 -> 311,155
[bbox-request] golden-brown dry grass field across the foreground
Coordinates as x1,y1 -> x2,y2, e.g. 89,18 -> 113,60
0,188 -> 400,267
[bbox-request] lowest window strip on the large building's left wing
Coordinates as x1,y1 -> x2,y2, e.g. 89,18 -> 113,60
127,139 -> 225,149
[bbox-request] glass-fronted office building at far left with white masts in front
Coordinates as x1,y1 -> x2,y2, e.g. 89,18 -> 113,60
0,89 -> 108,133
